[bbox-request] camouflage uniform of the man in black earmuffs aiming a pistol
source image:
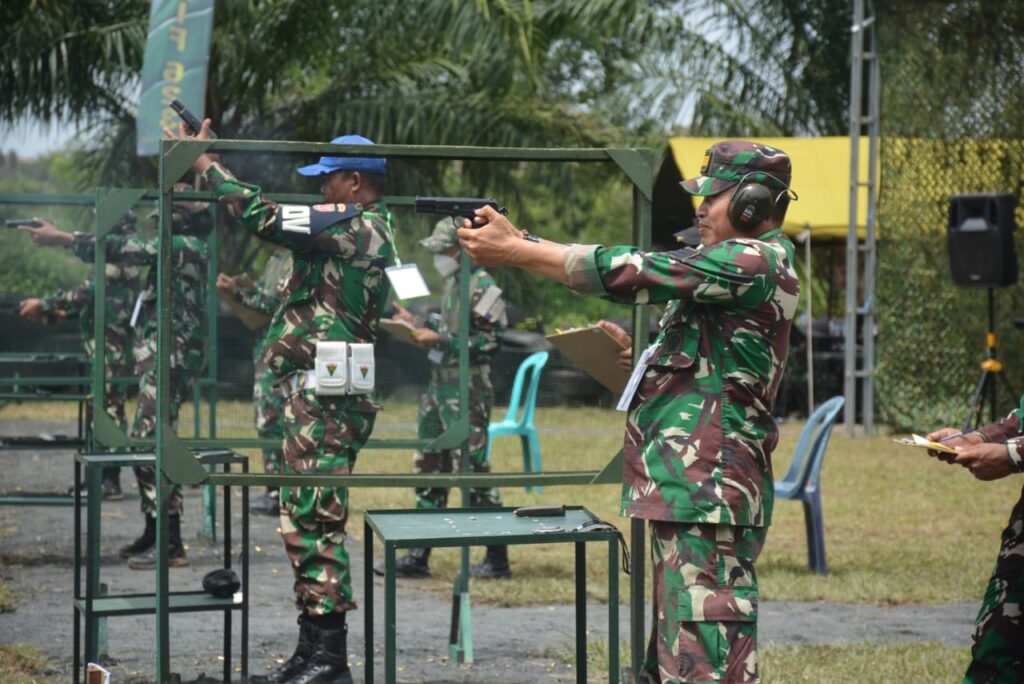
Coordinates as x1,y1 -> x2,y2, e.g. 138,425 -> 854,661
565,143 -> 800,682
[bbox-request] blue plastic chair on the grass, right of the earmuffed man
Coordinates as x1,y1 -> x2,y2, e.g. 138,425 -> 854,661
775,396 -> 845,574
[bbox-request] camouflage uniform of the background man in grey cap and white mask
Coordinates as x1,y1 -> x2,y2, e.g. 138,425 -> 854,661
413,266 -> 506,508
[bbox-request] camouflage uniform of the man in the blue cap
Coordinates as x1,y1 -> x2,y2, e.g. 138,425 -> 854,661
204,158 -> 396,615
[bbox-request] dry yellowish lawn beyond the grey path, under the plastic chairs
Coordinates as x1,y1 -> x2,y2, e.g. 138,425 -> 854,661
6,401 -> 1021,606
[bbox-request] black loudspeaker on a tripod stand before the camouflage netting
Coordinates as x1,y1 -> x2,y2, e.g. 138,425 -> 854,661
946,193 -> 1018,288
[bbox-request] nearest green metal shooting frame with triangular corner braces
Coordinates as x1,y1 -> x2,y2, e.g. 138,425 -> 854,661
146,139 -> 657,681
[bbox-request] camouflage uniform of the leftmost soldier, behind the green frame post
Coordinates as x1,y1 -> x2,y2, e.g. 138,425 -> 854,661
41,228 -> 142,438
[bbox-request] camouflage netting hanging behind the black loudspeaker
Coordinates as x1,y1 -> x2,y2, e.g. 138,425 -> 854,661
876,0 -> 1024,430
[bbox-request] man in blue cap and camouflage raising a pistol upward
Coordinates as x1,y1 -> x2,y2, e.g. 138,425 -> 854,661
167,121 -> 397,684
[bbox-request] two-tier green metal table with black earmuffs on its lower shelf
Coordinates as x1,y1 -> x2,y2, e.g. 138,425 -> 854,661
72,450 -> 249,684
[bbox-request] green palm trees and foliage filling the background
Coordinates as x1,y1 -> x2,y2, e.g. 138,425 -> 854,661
0,0 -> 848,325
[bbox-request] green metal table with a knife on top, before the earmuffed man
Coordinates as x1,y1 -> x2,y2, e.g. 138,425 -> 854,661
364,506 -> 618,684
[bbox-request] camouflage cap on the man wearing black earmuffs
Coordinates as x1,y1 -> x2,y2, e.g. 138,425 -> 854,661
680,140 -> 793,197
